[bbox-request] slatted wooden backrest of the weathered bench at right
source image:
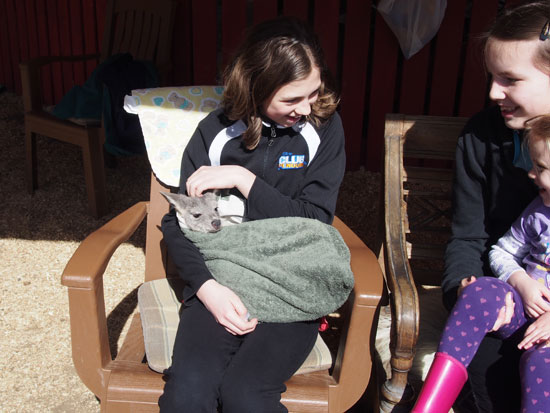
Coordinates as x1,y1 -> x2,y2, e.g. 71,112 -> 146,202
384,114 -> 466,286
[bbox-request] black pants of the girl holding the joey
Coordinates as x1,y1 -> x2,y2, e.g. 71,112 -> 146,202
159,300 -> 319,413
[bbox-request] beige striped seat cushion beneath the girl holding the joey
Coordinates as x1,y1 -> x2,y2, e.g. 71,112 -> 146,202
138,278 -> 332,374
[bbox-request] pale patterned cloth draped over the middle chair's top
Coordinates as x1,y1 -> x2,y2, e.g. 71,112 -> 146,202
124,86 -> 223,187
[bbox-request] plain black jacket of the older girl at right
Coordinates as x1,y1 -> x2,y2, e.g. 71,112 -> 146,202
442,106 -> 537,309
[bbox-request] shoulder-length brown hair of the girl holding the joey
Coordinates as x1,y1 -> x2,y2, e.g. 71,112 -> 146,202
223,17 -> 338,150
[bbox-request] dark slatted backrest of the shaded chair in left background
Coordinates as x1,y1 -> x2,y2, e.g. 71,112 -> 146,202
100,0 -> 176,78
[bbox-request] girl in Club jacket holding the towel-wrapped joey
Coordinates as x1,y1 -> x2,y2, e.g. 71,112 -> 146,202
159,18 -> 345,413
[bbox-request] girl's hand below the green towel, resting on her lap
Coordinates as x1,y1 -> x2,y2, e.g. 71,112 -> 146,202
197,279 -> 258,335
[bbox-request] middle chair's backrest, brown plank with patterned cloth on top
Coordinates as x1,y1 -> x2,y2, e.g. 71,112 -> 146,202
125,86 -> 223,281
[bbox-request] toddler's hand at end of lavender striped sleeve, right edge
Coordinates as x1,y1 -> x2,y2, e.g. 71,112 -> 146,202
508,270 -> 550,318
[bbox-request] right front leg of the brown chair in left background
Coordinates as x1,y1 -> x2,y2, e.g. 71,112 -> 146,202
82,128 -> 107,218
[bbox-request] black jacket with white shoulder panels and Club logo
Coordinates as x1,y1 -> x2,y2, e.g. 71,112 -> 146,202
162,109 -> 346,300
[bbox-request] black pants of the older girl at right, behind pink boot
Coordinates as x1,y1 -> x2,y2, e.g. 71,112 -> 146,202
455,335 -> 522,413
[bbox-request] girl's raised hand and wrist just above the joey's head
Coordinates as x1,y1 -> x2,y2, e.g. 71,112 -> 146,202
186,165 -> 256,199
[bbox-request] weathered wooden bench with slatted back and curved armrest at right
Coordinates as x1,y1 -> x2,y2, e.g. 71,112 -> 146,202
380,114 -> 466,412
